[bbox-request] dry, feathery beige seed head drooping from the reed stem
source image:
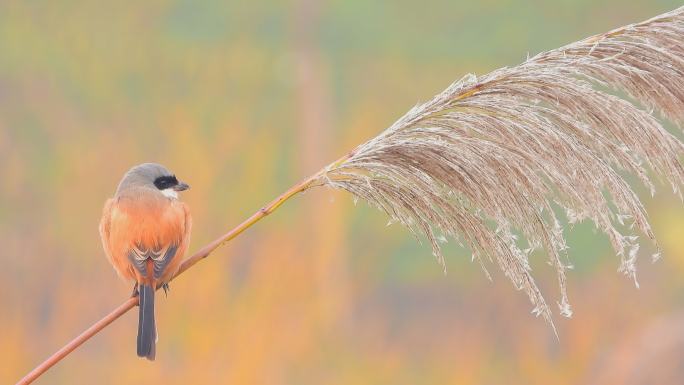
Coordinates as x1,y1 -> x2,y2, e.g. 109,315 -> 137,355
320,7 -> 684,331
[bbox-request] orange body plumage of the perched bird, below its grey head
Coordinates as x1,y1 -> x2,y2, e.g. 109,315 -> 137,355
100,191 -> 191,282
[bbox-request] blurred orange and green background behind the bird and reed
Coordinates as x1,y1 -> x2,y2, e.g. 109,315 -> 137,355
0,0 -> 684,384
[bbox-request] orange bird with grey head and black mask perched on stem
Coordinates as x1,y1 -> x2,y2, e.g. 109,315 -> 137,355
99,163 -> 192,361
